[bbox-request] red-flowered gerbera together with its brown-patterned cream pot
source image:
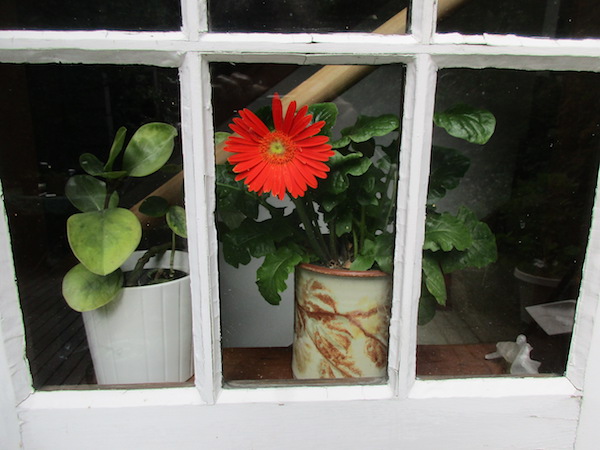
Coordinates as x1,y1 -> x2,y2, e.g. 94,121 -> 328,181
217,94 -> 493,378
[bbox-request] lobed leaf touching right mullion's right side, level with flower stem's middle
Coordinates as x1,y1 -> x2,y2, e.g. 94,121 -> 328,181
423,213 -> 472,252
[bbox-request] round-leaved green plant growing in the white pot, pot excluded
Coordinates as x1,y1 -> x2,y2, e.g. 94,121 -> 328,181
62,123 -> 186,311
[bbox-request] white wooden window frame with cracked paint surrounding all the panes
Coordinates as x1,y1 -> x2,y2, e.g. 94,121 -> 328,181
0,0 -> 600,449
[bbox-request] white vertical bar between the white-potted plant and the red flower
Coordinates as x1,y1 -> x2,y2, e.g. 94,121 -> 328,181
180,53 -> 221,403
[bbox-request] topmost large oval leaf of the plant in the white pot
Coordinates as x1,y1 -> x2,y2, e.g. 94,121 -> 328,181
123,122 -> 177,177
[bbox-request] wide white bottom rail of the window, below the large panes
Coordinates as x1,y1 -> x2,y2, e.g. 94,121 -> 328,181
21,393 -> 579,450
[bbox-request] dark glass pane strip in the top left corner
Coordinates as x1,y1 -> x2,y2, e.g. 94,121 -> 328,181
0,0 -> 181,31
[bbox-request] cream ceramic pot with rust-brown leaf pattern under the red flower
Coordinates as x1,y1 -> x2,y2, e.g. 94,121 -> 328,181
292,264 -> 392,379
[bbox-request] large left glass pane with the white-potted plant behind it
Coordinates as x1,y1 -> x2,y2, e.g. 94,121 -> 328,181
0,64 -> 191,388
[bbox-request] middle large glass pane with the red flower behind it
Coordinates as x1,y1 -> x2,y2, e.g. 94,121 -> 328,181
211,64 -> 404,381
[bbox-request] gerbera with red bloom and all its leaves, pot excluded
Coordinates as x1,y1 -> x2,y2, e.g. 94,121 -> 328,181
216,94 -> 495,322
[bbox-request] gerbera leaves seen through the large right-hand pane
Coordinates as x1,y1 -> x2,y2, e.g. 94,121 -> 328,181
419,105 -> 498,324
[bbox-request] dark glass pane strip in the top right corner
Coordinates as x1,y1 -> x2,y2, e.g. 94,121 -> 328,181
437,0 -> 600,38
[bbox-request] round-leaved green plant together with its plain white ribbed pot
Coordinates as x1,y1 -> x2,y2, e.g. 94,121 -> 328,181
62,123 -> 192,384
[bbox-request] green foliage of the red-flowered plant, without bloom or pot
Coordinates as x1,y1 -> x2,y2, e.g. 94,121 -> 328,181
216,103 -> 496,322
